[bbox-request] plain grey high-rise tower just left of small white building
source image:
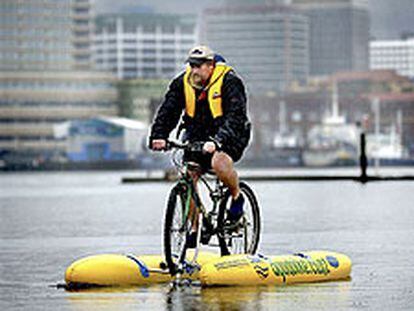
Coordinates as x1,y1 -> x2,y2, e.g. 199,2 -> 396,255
292,0 -> 369,76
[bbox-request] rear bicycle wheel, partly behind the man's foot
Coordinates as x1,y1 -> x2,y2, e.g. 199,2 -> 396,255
217,182 -> 260,256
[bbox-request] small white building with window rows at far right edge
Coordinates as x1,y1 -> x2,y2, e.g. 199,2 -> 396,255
370,38 -> 414,79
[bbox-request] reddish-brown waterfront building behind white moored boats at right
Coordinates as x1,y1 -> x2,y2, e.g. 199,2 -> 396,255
272,70 -> 414,155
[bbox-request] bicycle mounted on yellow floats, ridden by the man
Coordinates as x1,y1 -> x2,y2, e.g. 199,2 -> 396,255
164,140 -> 260,277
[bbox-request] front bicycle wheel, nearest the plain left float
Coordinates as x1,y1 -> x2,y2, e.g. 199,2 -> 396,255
164,184 -> 191,275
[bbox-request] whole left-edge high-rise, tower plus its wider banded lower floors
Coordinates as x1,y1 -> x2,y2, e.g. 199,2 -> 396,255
0,0 -> 117,163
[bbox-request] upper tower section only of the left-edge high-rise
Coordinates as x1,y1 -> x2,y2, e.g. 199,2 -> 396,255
0,0 -> 93,71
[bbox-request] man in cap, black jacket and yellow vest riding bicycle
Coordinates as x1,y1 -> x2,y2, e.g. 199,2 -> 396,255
150,46 -> 251,244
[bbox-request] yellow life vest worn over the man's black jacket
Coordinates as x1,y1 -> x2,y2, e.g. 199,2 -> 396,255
184,63 -> 233,119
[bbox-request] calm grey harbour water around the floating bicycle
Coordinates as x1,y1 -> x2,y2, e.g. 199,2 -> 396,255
0,172 -> 414,310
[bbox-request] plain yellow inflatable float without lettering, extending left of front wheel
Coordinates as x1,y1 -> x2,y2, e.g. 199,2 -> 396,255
65,252 -> 219,289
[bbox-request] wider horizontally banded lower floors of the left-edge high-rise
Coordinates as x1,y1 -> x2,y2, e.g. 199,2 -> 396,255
0,72 -> 117,156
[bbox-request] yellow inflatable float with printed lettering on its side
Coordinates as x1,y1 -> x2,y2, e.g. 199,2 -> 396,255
199,251 -> 352,286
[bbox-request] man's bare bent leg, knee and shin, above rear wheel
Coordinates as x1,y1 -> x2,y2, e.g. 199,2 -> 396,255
211,151 -> 240,199
